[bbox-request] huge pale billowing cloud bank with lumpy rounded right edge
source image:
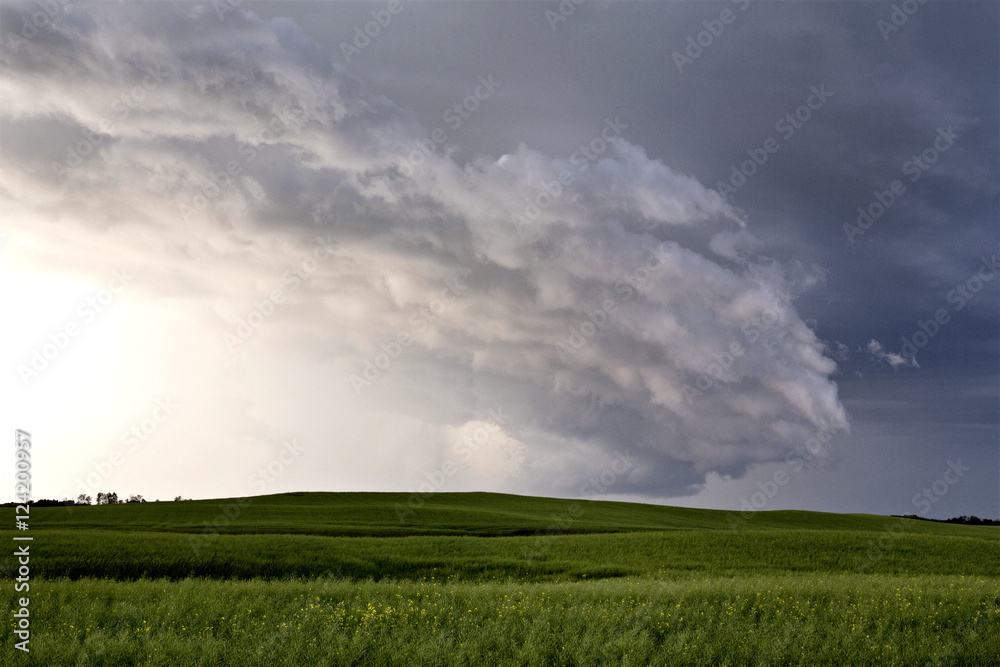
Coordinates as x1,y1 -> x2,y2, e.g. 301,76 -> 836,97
0,4 -> 847,496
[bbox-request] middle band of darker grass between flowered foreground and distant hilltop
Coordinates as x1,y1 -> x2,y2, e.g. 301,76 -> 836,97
1,530 -> 1000,581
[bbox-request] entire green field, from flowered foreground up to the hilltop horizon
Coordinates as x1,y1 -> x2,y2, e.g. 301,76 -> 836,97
0,493 -> 1000,665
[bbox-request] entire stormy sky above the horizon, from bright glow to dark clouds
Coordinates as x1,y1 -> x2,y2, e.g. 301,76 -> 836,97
0,0 -> 1000,518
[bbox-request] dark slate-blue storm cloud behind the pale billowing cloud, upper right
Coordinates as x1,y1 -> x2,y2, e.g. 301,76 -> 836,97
264,2 -> 1000,511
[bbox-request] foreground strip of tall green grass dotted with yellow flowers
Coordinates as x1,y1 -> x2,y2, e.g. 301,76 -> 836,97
4,575 -> 1000,666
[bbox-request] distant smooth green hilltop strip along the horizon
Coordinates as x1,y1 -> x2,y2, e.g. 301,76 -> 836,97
21,493 -> 1000,539
